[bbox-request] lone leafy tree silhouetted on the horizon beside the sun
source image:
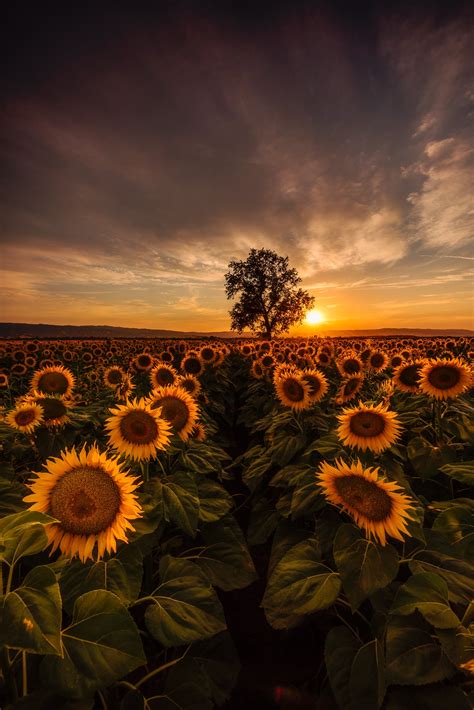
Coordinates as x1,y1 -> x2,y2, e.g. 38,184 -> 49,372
225,249 -> 314,338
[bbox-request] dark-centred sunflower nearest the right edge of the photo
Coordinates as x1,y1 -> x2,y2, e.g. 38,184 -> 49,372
420,358 -> 472,399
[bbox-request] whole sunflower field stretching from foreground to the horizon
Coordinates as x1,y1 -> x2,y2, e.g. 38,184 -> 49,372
0,337 -> 474,710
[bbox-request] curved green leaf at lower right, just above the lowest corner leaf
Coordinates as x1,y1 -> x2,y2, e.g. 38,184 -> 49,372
390,572 -> 460,629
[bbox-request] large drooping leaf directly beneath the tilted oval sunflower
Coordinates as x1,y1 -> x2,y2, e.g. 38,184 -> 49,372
334,525 -> 398,610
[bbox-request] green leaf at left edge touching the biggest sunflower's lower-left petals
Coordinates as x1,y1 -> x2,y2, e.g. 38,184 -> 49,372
0,510 -> 55,565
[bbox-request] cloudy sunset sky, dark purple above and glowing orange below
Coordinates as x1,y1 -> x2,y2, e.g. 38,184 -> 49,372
0,0 -> 474,333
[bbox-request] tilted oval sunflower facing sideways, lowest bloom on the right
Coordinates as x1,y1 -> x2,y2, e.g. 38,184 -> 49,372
316,460 -> 414,546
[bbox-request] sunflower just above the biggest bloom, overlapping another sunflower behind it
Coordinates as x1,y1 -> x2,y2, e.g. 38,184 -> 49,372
105,399 -> 170,461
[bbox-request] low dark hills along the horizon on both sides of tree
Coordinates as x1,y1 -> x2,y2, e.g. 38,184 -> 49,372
0,323 -> 474,339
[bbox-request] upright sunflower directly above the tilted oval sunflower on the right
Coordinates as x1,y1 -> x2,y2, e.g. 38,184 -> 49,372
337,404 -> 400,452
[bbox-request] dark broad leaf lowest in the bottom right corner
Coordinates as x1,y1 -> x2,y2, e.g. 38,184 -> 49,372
386,617 -> 454,685
